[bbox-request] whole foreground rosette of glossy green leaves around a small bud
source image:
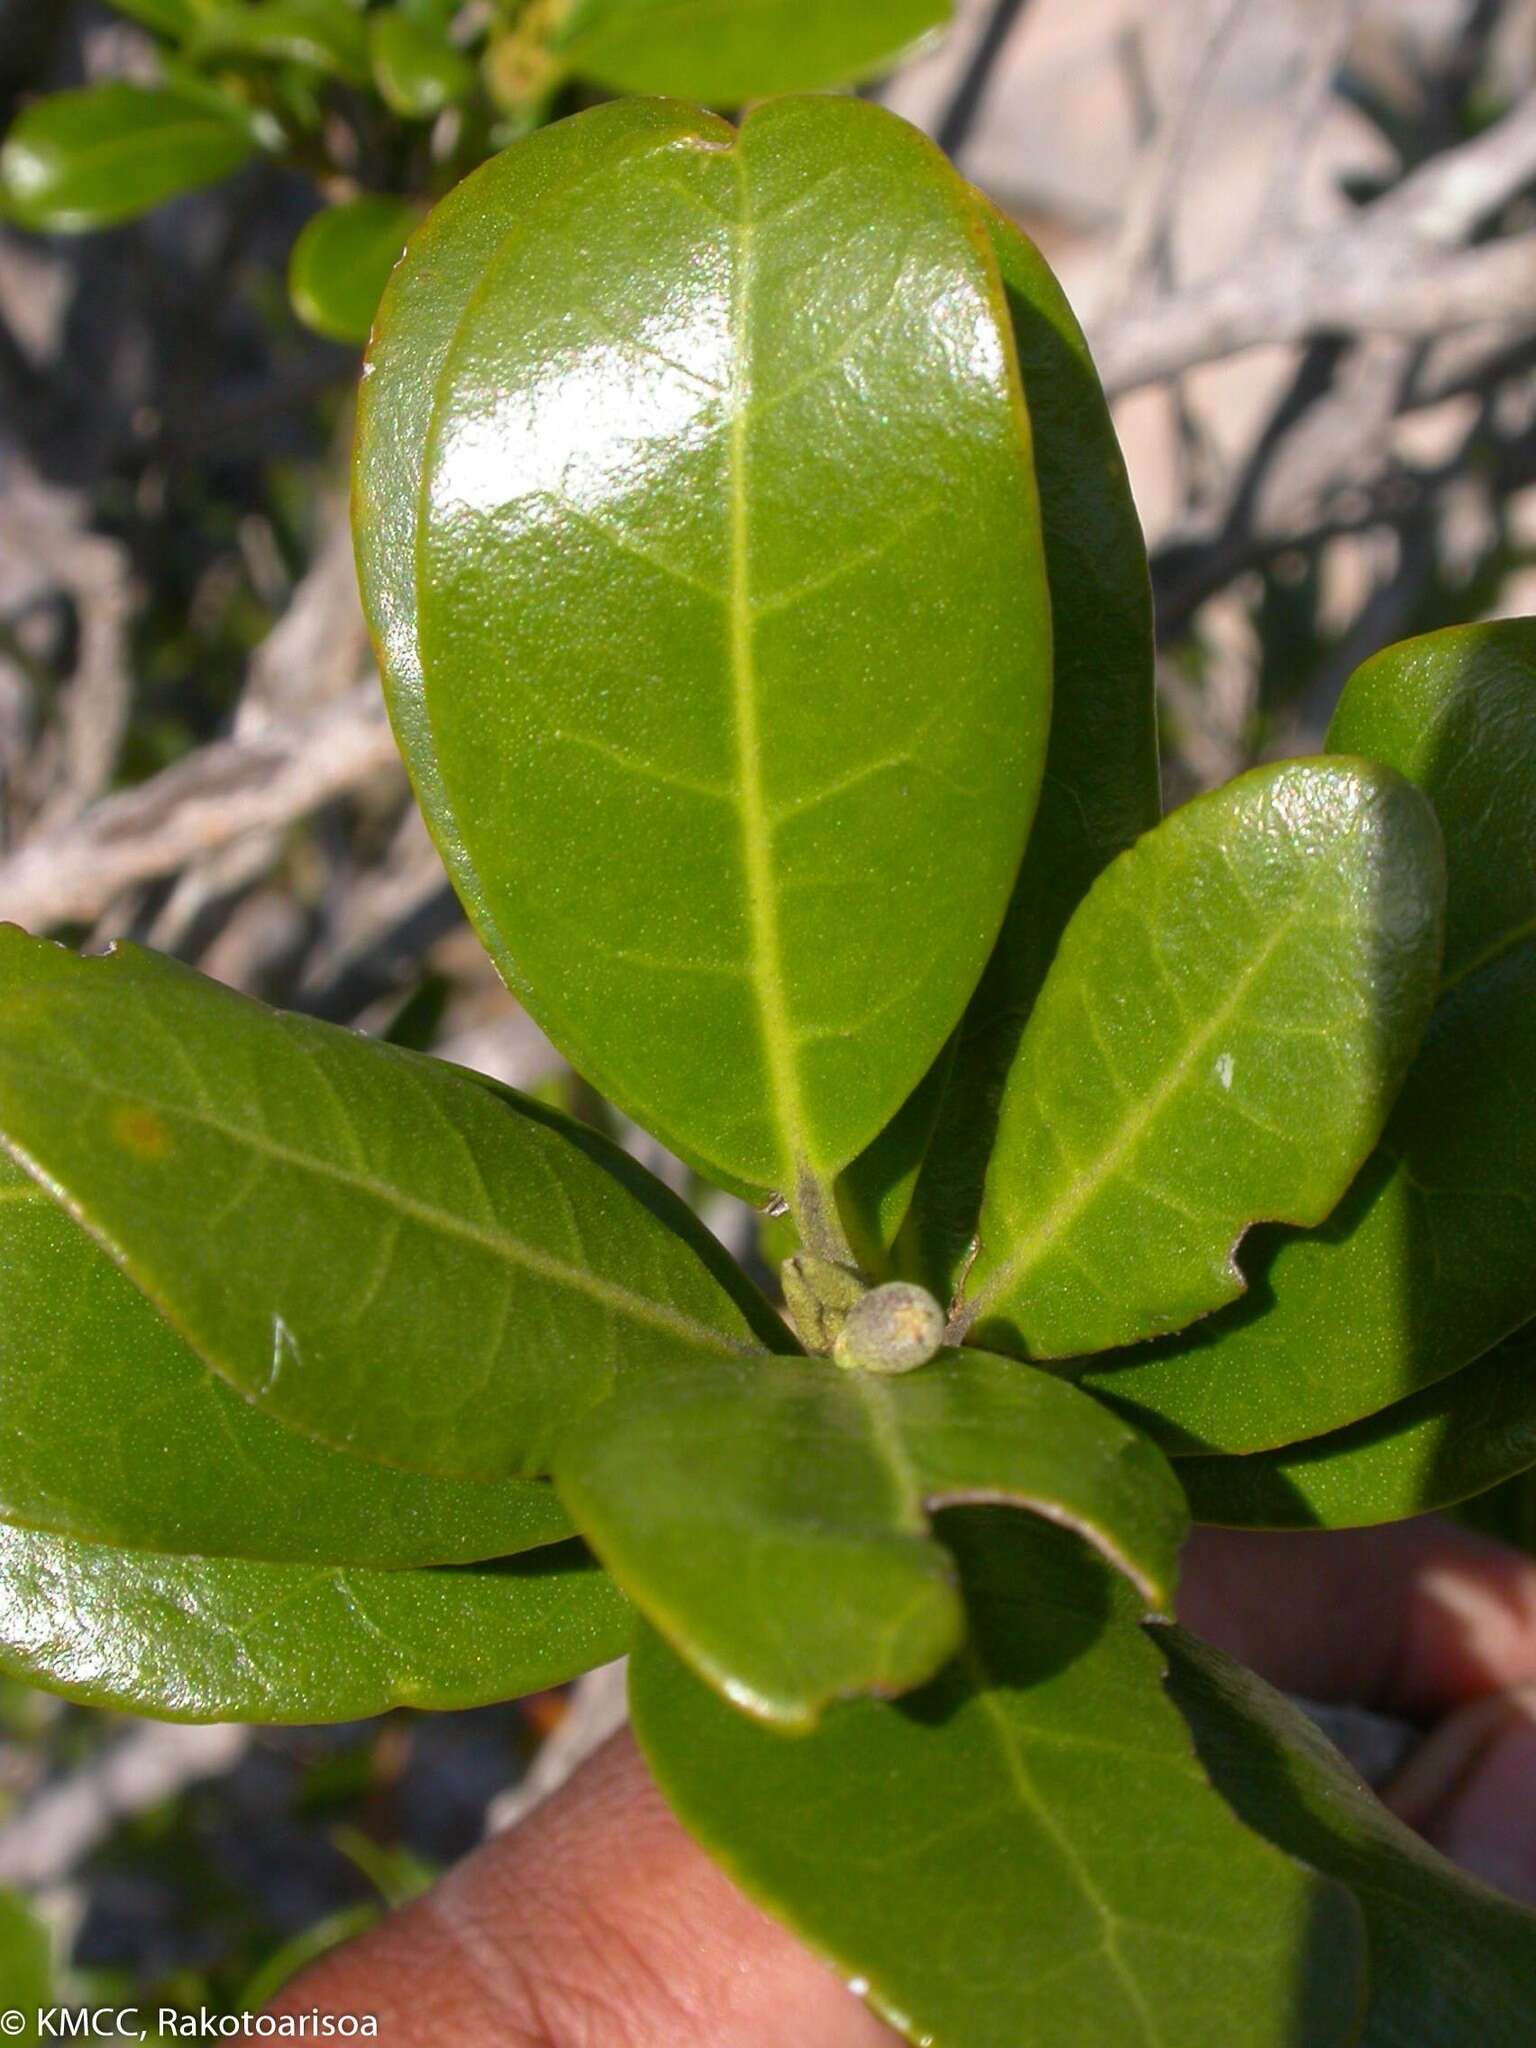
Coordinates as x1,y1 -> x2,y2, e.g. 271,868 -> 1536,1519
0,98 -> 1536,2048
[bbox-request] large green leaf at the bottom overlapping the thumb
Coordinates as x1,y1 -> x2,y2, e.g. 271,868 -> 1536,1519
631,1513 -> 1364,2048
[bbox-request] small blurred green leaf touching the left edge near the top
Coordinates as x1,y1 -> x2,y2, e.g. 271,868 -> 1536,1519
0,84 -> 256,233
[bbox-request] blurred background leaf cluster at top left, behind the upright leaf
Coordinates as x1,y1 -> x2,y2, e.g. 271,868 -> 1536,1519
0,0 -> 950,344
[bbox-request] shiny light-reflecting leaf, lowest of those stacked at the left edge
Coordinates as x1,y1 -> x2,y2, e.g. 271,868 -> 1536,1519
0,1528 -> 633,1722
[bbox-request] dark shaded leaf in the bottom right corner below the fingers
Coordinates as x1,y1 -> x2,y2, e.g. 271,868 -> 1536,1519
1155,1628 -> 1536,2048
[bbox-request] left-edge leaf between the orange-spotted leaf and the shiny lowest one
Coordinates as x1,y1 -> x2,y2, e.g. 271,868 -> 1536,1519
0,1155 -> 571,1569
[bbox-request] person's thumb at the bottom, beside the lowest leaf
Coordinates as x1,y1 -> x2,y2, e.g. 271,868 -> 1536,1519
268,1733 -> 897,2048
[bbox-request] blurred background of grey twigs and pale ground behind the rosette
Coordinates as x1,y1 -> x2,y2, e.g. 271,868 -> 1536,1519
0,0 -> 1536,2009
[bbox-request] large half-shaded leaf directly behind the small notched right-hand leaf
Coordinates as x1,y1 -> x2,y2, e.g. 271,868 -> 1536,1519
1090,621 -> 1536,1452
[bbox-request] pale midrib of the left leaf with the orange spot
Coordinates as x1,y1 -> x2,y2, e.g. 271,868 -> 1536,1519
0,1053 -> 766,1358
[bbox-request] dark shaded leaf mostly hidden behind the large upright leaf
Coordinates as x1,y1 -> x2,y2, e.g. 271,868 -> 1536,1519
860,201 -> 1161,1300
